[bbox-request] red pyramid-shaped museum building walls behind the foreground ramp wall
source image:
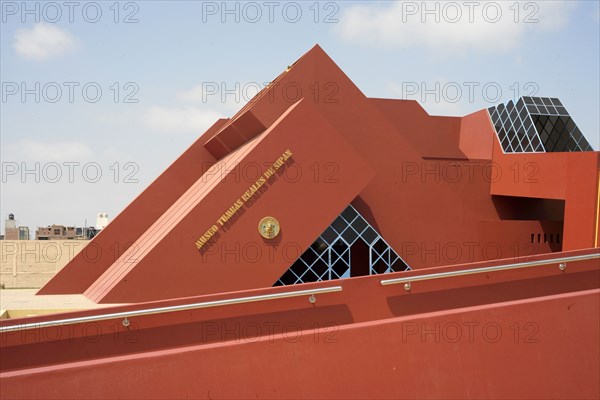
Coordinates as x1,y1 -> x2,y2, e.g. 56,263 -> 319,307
40,46 -> 599,302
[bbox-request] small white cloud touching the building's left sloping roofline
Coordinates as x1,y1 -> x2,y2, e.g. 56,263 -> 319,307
143,106 -> 222,135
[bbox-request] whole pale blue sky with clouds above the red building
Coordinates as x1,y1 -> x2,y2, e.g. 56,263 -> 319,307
0,1 -> 600,233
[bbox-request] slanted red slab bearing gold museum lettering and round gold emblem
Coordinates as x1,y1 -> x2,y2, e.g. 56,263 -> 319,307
85,102 -> 373,303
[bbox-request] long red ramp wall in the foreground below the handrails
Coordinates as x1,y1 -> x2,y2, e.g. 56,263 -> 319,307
0,250 -> 600,398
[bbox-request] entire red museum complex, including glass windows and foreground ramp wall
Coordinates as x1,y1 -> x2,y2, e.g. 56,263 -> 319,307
0,46 -> 600,398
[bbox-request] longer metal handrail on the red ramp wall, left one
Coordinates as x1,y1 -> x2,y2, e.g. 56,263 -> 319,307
0,286 -> 342,333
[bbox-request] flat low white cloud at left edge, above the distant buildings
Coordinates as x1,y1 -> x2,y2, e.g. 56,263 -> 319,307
3,139 -> 93,162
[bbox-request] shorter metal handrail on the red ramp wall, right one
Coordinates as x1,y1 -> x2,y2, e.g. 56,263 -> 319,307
380,253 -> 600,285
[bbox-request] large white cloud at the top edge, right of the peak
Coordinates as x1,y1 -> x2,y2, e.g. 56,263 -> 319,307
334,1 -> 573,54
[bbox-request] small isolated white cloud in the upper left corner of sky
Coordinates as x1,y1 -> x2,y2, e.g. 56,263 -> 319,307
13,23 -> 76,60
